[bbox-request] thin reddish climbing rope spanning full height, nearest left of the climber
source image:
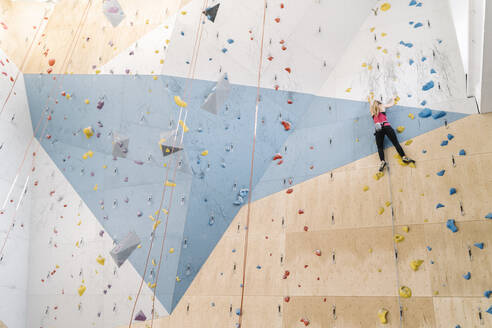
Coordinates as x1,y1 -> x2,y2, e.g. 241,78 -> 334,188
239,0 -> 267,327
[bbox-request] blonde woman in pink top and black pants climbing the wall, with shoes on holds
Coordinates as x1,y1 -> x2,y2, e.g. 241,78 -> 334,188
367,96 -> 415,172
